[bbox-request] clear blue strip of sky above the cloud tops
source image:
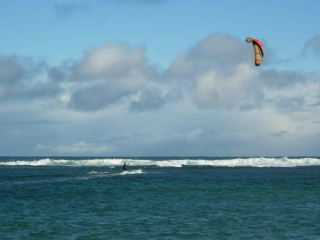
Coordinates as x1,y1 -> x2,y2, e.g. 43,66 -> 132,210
0,0 -> 320,66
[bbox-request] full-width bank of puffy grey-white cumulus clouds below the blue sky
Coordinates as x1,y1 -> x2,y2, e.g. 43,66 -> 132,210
0,34 -> 320,116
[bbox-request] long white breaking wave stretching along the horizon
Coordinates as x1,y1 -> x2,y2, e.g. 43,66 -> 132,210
0,157 -> 320,168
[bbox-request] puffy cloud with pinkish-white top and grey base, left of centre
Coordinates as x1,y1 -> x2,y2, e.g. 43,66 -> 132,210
69,44 -> 162,111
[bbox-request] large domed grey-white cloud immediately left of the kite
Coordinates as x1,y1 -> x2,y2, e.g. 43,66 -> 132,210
167,34 -> 261,108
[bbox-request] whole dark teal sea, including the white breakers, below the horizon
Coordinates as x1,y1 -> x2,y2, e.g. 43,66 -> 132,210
0,157 -> 320,240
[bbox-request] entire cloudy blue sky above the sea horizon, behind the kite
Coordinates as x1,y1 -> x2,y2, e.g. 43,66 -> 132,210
0,0 -> 320,156
